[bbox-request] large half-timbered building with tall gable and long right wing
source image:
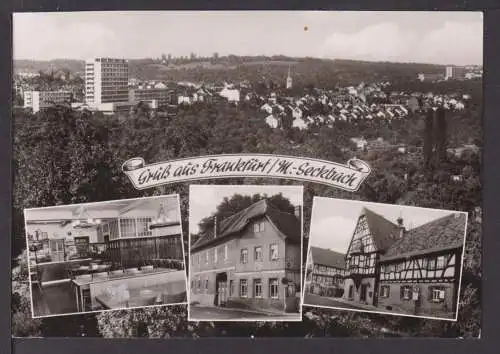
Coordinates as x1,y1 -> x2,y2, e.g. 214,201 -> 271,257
343,208 -> 467,317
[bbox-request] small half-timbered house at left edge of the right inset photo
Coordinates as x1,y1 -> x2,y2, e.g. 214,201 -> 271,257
306,246 -> 346,297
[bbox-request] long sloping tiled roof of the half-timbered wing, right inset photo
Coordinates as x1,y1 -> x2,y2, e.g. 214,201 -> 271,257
381,213 -> 467,261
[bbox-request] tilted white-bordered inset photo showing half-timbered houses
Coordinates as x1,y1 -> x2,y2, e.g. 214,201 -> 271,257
303,197 -> 467,321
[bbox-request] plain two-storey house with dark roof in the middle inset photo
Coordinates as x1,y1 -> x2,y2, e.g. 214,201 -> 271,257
190,200 -> 302,312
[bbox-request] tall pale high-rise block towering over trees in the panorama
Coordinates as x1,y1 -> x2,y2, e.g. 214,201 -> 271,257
85,58 -> 129,109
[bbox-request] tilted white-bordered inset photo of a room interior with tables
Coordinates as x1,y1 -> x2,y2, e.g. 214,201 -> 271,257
24,195 -> 187,317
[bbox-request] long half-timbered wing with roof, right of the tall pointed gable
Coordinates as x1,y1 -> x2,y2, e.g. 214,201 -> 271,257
378,213 -> 467,317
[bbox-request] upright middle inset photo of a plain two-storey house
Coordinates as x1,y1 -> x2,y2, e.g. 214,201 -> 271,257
188,185 -> 303,321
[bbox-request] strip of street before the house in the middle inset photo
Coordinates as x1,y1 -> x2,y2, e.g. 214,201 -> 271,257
189,306 -> 301,321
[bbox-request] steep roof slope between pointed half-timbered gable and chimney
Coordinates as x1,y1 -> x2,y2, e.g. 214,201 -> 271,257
361,208 -> 400,252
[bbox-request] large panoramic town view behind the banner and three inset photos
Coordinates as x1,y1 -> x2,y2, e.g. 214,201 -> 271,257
12,12 -> 483,338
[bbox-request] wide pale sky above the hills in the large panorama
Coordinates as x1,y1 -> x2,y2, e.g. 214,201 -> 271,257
13,11 -> 483,65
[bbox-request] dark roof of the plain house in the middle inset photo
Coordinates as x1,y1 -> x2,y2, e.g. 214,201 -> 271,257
191,199 -> 302,251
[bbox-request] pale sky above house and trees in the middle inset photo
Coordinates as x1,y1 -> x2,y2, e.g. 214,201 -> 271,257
189,185 -> 303,234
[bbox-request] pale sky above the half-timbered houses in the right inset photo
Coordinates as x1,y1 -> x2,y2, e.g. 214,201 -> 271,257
309,197 -> 464,253
